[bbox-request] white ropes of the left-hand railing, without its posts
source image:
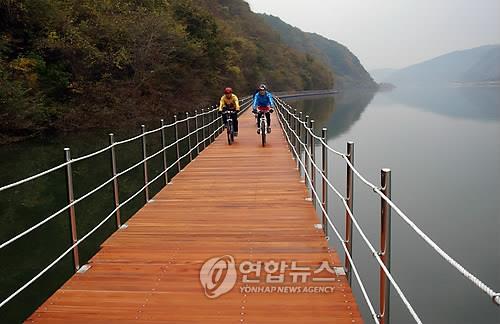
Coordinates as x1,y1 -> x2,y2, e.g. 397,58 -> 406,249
0,97 -> 251,308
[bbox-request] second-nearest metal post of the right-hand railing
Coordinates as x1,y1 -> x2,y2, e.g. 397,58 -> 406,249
344,141 -> 354,285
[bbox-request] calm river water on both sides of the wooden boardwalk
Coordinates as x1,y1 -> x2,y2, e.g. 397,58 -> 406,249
0,88 -> 500,324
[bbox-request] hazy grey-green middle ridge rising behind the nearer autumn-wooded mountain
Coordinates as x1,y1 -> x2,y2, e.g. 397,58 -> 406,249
260,14 -> 377,88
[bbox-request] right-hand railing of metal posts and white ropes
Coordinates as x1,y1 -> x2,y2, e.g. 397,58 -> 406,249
275,98 -> 500,324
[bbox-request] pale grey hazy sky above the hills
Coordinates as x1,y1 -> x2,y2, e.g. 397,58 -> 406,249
247,0 -> 500,70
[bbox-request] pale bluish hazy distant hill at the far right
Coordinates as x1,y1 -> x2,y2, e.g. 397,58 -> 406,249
377,45 -> 500,86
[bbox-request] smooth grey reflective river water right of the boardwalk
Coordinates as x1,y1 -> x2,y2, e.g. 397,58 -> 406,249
288,88 -> 500,324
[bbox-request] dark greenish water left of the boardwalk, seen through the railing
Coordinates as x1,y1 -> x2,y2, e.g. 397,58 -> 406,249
0,116 -> 203,324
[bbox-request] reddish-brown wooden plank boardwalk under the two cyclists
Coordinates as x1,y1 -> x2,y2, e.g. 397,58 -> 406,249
27,113 -> 363,324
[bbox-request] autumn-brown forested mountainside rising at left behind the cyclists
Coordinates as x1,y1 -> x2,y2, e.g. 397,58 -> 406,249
0,0 -> 333,142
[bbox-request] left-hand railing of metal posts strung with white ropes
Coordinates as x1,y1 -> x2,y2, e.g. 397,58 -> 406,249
0,97 -> 251,308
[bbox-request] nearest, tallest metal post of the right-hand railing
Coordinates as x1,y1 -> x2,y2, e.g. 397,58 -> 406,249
379,169 -> 391,324
